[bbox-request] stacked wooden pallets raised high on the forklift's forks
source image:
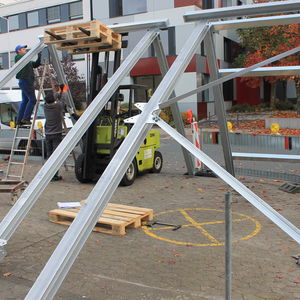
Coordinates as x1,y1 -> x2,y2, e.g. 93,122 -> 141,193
44,20 -> 122,55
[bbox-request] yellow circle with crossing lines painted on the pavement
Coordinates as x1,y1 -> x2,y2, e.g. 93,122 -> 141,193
142,208 -> 261,247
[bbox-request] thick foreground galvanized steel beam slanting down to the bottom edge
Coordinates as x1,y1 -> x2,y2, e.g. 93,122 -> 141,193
25,24 -> 208,300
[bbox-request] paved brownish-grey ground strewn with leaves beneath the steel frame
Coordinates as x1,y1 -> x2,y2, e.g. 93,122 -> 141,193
0,142 -> 300,300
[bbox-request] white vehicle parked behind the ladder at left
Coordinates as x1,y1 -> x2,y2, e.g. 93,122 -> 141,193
0,90 -> 73,155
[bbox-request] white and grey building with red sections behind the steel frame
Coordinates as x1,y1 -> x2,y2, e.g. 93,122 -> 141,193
0,0 -> 268,119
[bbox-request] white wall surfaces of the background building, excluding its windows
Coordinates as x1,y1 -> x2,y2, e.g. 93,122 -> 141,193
0,0 -> 252,116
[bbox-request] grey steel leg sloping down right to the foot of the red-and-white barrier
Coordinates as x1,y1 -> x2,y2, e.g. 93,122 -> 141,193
153,36 -> 195,175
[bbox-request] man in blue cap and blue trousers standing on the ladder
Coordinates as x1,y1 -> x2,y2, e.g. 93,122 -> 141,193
15,45 -> 41,126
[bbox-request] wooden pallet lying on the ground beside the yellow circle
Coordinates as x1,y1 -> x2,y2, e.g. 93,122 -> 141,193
48,203 -> 153,235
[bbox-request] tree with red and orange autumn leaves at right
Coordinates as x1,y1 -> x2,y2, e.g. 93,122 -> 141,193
235,0 -> 300,113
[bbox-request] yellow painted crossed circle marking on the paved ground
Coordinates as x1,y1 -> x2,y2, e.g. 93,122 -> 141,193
142,208 -> 261,247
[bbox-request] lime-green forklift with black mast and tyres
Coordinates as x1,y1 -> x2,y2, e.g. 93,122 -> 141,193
75,50 -> 163,186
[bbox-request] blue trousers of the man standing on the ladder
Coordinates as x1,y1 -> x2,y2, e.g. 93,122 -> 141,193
17,79 -> 36,122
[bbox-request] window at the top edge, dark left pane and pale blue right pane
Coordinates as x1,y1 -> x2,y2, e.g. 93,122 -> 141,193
109,0 -> 147,18
